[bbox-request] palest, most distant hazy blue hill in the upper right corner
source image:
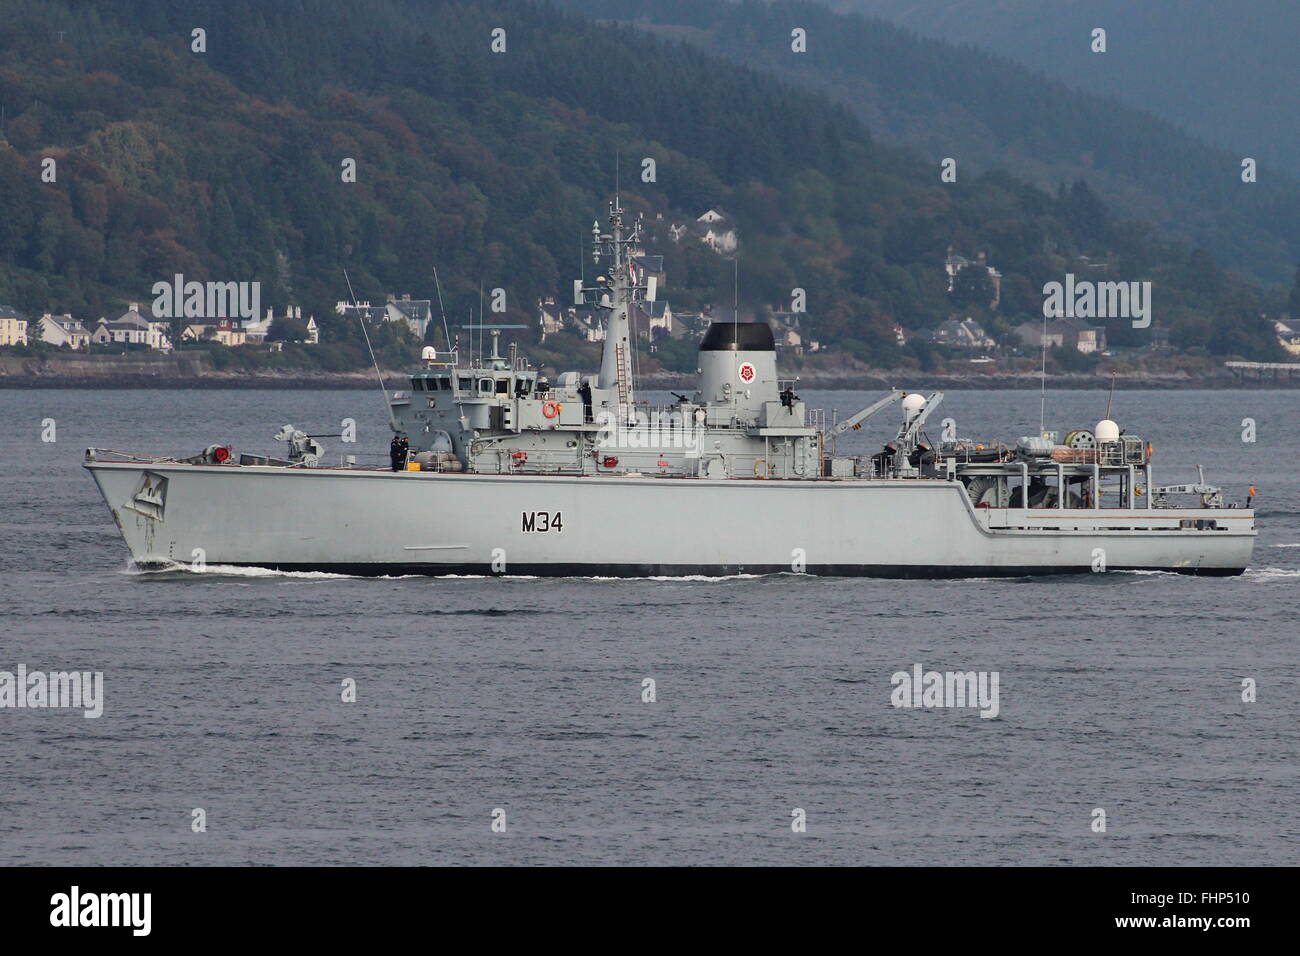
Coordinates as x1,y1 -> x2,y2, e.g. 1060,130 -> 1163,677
829,0 -> 1300,176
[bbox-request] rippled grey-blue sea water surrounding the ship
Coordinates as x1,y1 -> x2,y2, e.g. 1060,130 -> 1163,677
0,389 -> 1300,865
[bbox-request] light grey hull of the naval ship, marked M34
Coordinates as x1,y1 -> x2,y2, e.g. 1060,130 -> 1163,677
86,460 -> 1255,578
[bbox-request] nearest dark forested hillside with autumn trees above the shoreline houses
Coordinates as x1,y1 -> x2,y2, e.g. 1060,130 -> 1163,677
0,0 -> 1282,363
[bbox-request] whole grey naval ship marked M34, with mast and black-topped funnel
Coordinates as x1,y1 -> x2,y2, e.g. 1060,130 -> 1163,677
85,199 -> 1256,578
